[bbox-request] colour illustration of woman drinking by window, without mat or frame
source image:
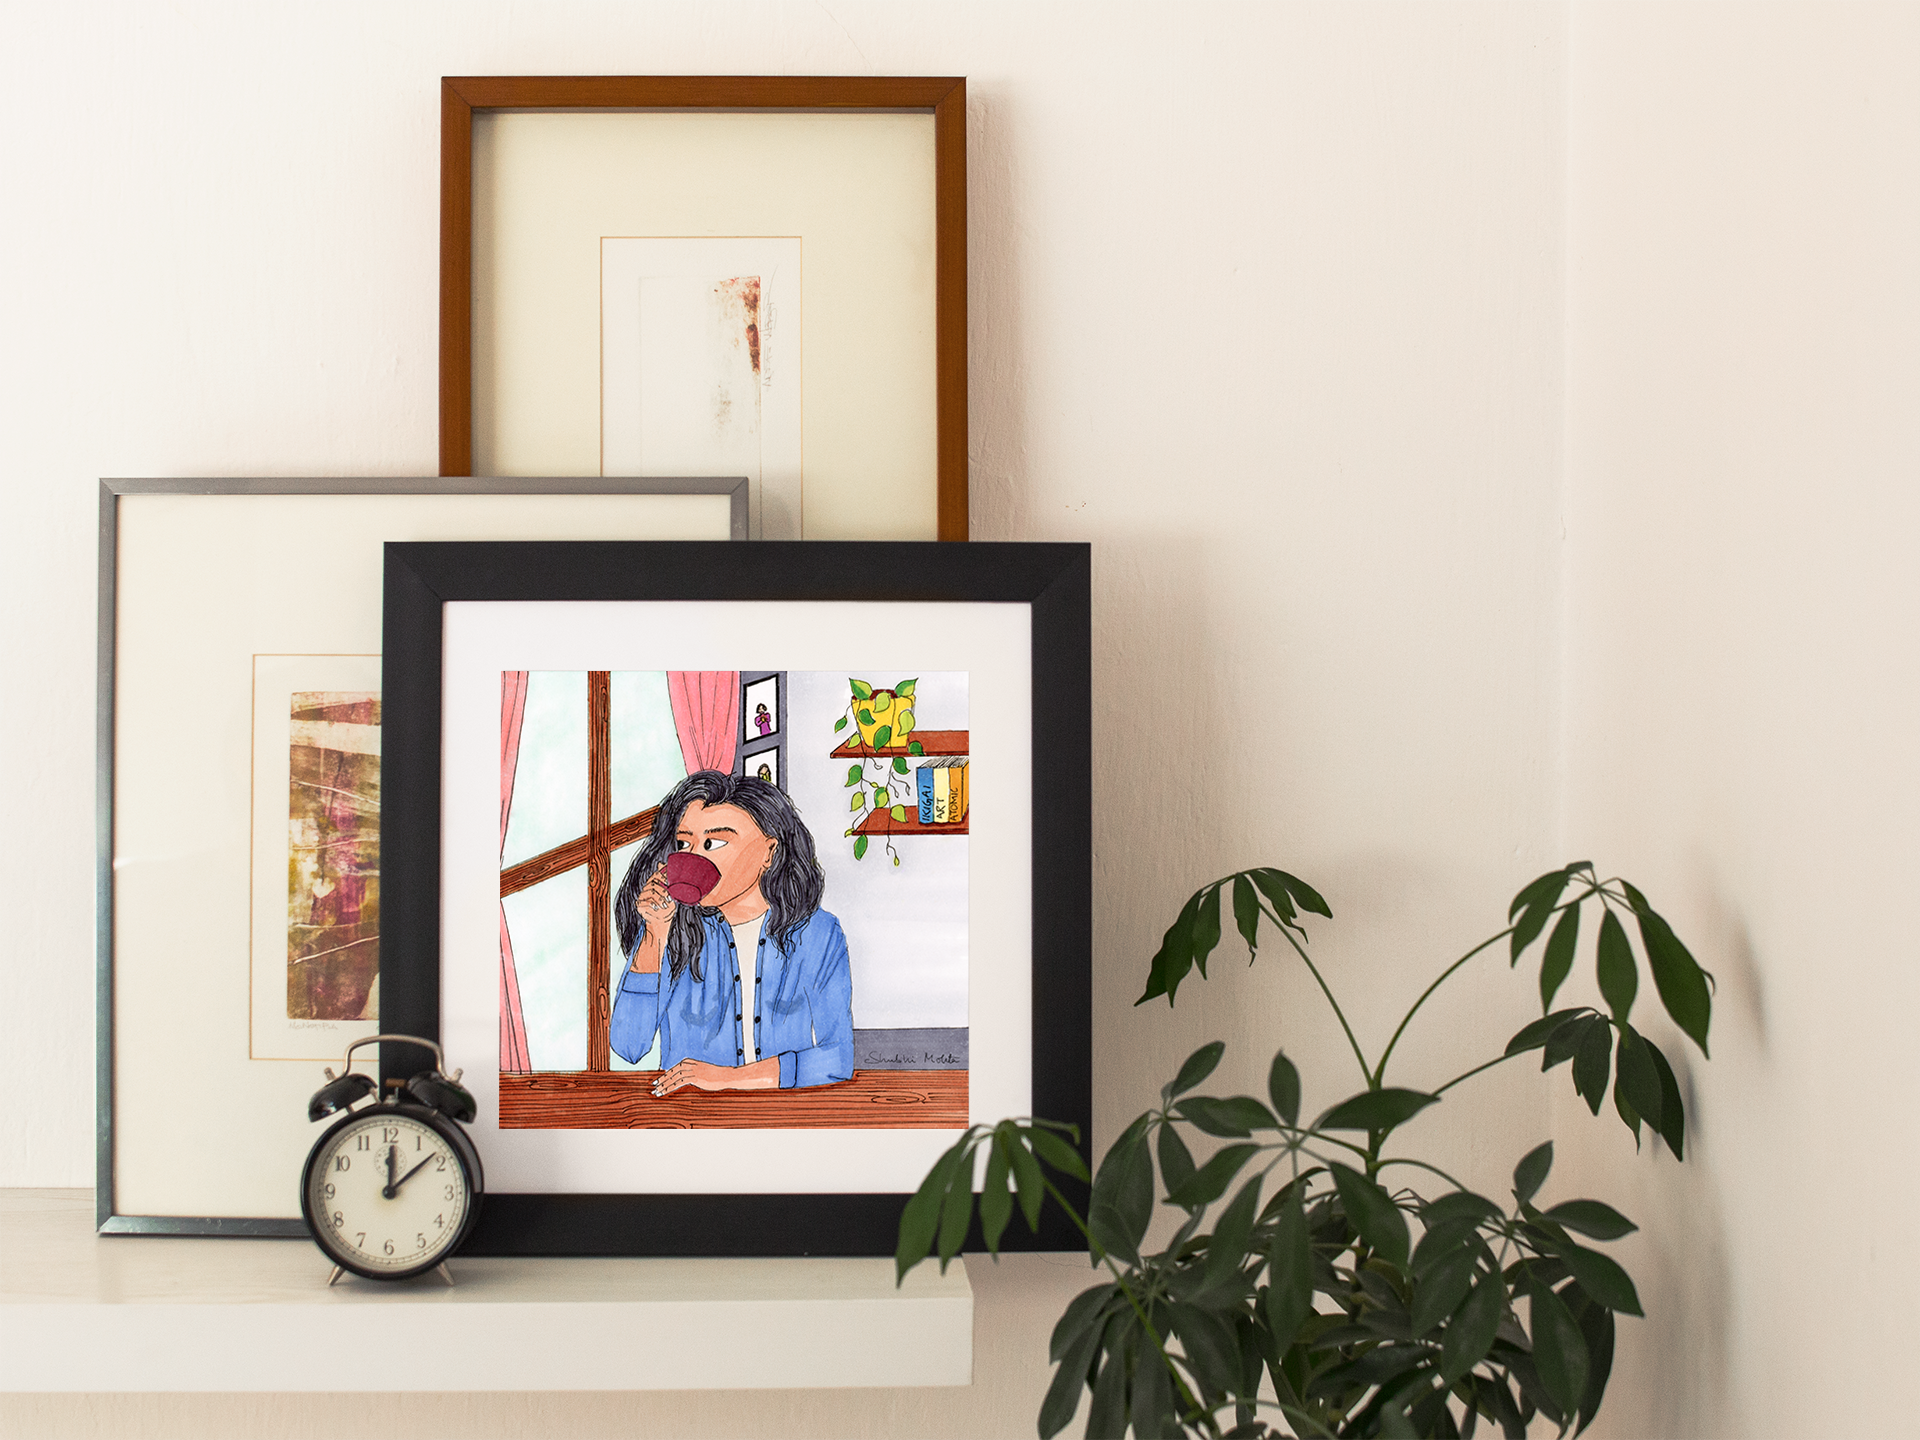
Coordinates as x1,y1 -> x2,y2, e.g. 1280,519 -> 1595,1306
499,668 -> 968,1129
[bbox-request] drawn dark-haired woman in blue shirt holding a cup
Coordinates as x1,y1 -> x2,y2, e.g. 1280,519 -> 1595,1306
611,770 -> 852,1094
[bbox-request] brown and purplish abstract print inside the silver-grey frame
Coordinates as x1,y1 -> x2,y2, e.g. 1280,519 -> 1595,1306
286,691 -> 380,1020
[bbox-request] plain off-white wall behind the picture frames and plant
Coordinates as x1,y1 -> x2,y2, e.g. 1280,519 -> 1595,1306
0,0 -> 1920,1440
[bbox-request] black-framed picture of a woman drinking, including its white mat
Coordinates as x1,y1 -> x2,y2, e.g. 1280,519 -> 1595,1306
380,541 -> 1091,1254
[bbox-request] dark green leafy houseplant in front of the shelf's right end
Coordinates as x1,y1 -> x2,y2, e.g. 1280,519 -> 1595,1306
897,862 -> 1713,1440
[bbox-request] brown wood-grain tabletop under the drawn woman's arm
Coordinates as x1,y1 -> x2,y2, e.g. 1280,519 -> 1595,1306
499,1069 -> 968,1131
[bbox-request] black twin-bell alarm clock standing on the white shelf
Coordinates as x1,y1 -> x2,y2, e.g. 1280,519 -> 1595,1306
300,1035 -> 486,1284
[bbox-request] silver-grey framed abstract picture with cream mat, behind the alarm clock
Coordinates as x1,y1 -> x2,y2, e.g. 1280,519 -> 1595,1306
96,478 -> 747,1235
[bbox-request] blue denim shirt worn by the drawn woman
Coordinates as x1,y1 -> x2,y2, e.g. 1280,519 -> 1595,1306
611,910 -> 852,1091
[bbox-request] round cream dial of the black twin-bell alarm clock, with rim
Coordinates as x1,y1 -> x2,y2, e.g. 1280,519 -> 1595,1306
301,1106 -> 472,1279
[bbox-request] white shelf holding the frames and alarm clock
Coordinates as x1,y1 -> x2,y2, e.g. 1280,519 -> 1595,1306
0,1190 -> 973,1392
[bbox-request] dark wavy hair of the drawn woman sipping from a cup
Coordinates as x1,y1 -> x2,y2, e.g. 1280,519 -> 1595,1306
612,770 -> 828,979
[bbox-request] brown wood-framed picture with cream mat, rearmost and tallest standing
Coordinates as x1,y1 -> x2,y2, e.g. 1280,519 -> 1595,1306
440,75 -> 968,540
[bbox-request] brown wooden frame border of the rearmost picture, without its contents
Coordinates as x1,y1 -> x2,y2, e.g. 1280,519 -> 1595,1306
440,75 -> 968,540
